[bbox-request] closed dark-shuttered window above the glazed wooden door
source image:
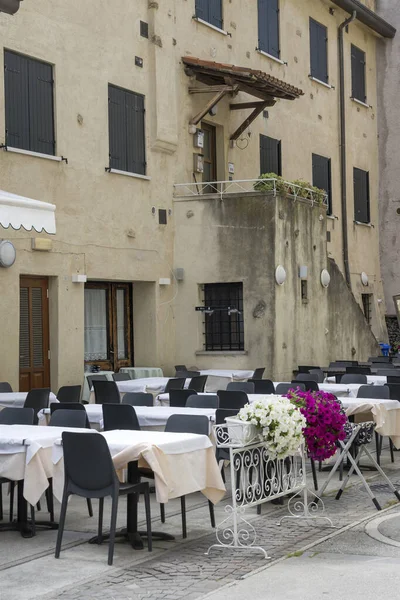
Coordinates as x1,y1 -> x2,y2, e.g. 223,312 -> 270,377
108,85 -> 146,175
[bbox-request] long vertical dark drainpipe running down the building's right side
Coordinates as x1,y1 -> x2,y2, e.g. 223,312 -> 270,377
339,11 -> 357,289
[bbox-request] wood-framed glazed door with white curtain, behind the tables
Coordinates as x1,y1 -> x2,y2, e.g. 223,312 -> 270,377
85,282 -> 133,372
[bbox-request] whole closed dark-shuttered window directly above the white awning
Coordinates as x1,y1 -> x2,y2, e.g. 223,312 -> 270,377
4,50 -> 55,155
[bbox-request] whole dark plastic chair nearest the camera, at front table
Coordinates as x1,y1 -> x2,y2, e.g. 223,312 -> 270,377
55,431 -> 152,565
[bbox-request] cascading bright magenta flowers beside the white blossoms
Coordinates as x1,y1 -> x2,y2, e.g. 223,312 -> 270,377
287,389 -> 347,461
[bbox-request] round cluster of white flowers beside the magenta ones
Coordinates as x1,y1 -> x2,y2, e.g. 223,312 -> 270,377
238,395 -> 306,459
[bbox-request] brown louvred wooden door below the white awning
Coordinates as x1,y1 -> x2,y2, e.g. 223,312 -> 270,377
19,277 -> 50,392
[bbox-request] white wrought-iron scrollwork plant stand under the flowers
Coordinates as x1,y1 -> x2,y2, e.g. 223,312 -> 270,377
206,423 -> 333,558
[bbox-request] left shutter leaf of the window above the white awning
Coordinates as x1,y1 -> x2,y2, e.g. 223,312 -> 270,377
4,50 -> 30,150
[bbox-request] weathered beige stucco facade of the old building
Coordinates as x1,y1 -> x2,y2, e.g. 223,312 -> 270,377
0,0 -> 394,390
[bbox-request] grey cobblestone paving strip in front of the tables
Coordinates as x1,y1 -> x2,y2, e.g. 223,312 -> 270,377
43,465 -> 400,600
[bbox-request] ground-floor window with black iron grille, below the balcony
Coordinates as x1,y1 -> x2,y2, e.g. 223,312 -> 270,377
204,283 -> 244,351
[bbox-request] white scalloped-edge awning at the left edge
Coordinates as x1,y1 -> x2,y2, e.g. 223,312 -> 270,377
0,190 -> 56,233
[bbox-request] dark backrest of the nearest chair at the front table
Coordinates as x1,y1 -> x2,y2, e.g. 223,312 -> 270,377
61,431 -> 117,495
